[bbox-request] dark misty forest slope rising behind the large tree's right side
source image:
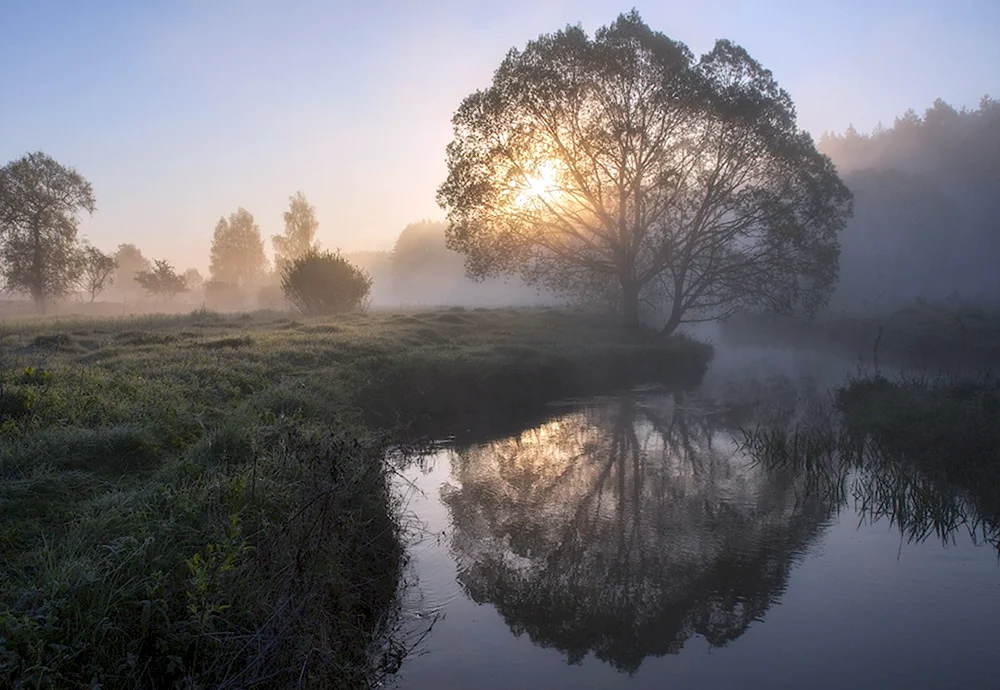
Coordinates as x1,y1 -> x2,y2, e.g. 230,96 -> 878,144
819,97 -> 1000,312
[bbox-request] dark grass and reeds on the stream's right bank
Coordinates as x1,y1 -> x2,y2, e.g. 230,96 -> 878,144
743,371 -> 1000,551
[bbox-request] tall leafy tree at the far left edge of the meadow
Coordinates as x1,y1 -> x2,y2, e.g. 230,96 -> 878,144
0,151 -> 96,312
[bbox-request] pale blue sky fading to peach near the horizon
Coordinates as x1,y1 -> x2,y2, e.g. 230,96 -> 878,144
0,0 -> 1000,271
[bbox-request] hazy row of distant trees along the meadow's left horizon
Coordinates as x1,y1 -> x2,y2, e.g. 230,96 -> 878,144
0,152 -> 544,313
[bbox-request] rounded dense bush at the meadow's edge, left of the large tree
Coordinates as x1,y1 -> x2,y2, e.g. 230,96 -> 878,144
281,251 -> 372,315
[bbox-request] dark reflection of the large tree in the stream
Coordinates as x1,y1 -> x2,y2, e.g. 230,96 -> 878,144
442,394 -> 830,672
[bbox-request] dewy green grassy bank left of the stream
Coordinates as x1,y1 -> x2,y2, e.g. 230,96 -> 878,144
0,310 -> 710,688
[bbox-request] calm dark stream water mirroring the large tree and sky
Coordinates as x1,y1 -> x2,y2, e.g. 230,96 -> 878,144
396,350 -> 1000,690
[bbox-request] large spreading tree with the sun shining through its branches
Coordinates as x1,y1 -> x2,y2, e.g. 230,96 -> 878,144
438,11 -> 851,331
